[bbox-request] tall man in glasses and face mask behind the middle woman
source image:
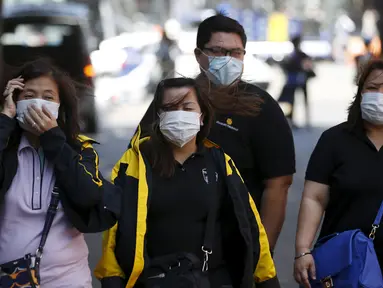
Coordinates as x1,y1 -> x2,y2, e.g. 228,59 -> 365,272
140,14 -> 295,251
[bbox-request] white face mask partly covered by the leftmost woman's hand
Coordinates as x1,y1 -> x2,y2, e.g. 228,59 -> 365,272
16,99 -> 60,133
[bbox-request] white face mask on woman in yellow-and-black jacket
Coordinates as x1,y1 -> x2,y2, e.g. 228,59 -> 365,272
160,111 -> 201,148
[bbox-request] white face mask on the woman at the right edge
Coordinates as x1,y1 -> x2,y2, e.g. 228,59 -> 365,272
360,92 -> 383,125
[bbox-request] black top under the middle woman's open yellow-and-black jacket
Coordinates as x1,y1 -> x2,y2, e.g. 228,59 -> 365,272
147,148 -> 227,269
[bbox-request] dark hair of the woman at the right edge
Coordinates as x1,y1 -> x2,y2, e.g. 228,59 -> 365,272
347,59 -> 383,129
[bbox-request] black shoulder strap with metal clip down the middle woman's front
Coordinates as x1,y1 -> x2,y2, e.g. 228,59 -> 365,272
202,149 -> 225,272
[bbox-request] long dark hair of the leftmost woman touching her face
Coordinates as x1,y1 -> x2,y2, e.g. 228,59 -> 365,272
0,58 -> 80,146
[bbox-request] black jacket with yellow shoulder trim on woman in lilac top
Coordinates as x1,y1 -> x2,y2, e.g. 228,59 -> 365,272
0,113 -> 119,233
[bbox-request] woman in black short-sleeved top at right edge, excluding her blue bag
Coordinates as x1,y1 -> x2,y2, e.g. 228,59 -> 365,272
294,60 -> 383,287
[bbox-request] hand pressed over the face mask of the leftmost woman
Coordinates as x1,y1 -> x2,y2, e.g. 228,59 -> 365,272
25,105 -> 58,136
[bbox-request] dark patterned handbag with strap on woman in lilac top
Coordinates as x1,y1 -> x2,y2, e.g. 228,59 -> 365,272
0,187 -> 60,288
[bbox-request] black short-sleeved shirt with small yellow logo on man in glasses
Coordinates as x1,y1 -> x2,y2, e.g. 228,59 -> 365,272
141,82 -> 295,208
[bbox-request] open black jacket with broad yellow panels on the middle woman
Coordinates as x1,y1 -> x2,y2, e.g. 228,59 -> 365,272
95,129 -> 279,288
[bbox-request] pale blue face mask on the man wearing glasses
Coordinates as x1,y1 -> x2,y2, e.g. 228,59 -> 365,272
202,56 -> 243,86
